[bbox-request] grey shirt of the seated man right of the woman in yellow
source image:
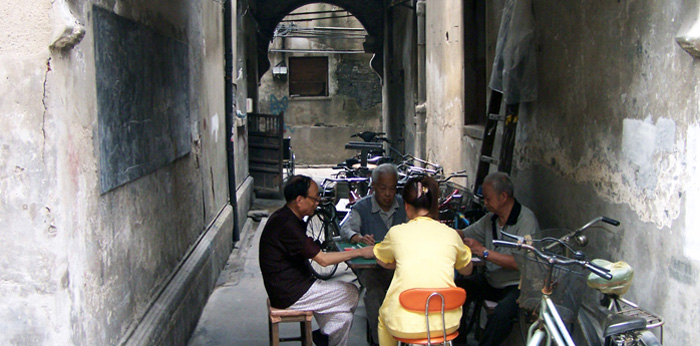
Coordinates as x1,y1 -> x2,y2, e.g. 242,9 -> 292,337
463,201 -> 539,288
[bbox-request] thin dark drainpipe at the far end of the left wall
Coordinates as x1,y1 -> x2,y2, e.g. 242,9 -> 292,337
224,0 -> 240,242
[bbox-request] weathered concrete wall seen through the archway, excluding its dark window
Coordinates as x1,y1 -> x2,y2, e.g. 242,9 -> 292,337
258,4 -> 382,165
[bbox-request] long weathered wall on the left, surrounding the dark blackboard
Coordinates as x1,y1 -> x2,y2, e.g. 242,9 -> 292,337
0,0 -> 249,345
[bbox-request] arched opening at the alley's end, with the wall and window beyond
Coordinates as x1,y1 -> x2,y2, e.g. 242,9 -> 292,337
258,2 -> 383,165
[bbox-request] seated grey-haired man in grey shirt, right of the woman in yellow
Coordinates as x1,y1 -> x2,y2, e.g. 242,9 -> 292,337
455,172 -> 539,345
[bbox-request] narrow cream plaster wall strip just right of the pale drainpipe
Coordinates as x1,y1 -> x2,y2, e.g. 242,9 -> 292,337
426,0 -> 466,177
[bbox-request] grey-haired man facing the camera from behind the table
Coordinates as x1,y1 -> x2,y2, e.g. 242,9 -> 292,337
340,163 -> 407,344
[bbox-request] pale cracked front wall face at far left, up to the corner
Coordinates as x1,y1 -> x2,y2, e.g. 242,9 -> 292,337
0,1 -> 65,344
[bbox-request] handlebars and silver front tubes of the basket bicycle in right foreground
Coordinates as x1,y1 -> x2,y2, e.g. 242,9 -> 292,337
493,227 -> 612,346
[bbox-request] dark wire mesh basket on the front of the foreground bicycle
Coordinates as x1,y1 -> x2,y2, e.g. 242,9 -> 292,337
516,251 -> 586,323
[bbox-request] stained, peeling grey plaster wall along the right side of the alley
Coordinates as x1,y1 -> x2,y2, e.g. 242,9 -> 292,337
498,0 -> 700,345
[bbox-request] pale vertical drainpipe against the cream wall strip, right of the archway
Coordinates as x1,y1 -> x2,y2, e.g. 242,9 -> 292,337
414,0 -> 427,159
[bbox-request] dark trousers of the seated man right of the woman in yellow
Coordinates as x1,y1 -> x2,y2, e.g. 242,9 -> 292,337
455,273 -> 520,346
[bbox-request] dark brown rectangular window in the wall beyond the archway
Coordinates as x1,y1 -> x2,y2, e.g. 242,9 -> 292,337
289,56 -> 328,96
